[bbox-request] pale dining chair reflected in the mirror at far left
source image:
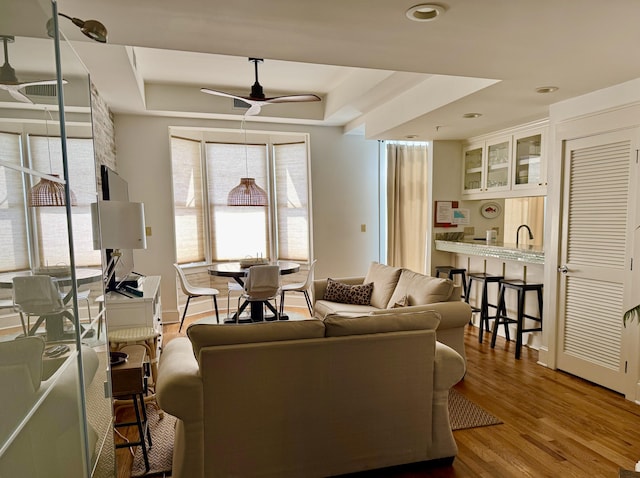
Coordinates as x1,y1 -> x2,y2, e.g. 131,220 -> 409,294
13,275 -> 73,335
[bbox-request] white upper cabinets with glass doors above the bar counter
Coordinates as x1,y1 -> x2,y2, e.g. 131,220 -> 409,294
462,128 -> 547,199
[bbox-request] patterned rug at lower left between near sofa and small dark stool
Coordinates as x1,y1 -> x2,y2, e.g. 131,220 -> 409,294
131,405 -> 176,478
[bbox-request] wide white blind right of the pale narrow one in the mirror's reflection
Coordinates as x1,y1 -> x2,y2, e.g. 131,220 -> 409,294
29,136 -> 101,266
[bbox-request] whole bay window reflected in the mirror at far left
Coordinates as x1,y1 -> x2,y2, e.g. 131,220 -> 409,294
0,133 -> 101,272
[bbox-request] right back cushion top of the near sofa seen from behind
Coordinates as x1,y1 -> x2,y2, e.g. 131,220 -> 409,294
324,310 -> 440,337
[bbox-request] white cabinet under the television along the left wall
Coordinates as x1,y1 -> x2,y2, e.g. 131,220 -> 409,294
106,276 -> 162,346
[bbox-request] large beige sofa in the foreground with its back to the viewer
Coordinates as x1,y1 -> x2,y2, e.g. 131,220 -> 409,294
156,311 -> 465,478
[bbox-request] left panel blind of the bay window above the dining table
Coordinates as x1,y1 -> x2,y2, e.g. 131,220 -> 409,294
171,137 -> 205,263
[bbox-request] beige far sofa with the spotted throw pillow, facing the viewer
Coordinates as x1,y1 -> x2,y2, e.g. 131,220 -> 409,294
313,262 -> 471,361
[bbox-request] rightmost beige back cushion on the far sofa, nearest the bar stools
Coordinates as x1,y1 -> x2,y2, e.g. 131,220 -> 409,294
387,269 -> 453,308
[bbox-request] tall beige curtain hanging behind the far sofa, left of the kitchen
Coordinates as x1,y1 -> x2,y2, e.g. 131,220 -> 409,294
387,143 -> 427,273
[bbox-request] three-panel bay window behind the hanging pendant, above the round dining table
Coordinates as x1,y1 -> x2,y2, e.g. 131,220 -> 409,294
171,132 -> 310,264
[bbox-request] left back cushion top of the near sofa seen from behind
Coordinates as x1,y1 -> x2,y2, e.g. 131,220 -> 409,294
187,319 -> 324,360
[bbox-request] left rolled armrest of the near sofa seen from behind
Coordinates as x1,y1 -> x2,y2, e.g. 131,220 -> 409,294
156,337 -> 204,422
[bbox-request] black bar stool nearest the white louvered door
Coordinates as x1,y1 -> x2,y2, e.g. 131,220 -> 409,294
491,279 -> 543,359
